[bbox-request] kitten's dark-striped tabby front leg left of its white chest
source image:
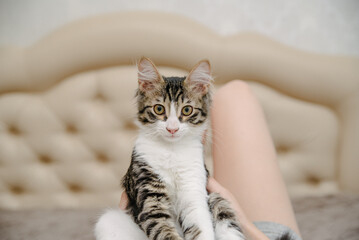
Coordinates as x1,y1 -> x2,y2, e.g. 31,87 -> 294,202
124,160 -> 183,240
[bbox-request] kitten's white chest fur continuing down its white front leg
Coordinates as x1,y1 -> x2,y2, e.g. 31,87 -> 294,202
136,136 -> 214,240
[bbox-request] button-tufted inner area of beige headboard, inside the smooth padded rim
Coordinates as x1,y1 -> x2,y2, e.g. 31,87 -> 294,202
0,67 -> 348,207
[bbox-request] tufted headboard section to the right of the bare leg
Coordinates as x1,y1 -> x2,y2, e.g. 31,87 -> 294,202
251,83 -> 339,196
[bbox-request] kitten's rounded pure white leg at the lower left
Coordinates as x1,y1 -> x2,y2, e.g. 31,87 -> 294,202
95,209 -> 148,240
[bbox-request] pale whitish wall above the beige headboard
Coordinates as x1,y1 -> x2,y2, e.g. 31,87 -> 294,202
0,0 -> 359,56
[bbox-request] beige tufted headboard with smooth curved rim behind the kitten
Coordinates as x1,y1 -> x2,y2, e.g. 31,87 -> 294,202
0,12 -> 359,209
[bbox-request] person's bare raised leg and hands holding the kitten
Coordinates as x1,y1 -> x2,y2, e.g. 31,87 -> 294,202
120,81 -> 300,240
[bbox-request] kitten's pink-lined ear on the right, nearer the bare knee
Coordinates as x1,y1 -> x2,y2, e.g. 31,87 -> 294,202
185,60 -> 213,95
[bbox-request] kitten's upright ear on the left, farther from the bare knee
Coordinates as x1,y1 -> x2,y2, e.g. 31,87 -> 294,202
137,57 -> 163,93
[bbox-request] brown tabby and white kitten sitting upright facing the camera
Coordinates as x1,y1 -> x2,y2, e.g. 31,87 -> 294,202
95,58 -> 245,240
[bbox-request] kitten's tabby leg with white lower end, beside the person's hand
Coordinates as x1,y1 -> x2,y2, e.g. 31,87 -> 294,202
208,193 -> 245,240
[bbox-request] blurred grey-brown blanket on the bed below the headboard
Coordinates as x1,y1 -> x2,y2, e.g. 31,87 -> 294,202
0,195 -> 359,240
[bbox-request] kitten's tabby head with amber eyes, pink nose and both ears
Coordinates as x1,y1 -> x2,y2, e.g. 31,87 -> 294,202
137,58 -> 212,142
